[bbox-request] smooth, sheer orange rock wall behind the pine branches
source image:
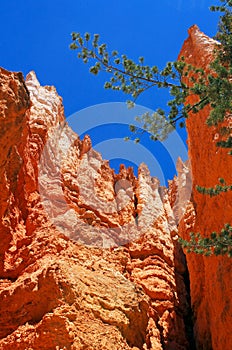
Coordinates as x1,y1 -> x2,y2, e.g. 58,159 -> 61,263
179,26 -> 232,350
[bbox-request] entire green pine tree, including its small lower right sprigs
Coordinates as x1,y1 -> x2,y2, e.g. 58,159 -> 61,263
70,0 -> 232,257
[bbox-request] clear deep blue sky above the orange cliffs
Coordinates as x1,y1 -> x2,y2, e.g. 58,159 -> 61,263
0,0 -> 219,183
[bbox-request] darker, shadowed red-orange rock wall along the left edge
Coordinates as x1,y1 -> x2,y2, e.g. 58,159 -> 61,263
0,70 -> 30,274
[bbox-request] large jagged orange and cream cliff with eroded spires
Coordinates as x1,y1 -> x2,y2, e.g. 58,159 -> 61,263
0,69 -> 189,350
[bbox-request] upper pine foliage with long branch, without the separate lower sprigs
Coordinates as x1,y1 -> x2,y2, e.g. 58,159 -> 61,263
70,1 -> 232,140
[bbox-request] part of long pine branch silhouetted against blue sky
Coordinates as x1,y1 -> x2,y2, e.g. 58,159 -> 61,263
70,33 -> 192,139
